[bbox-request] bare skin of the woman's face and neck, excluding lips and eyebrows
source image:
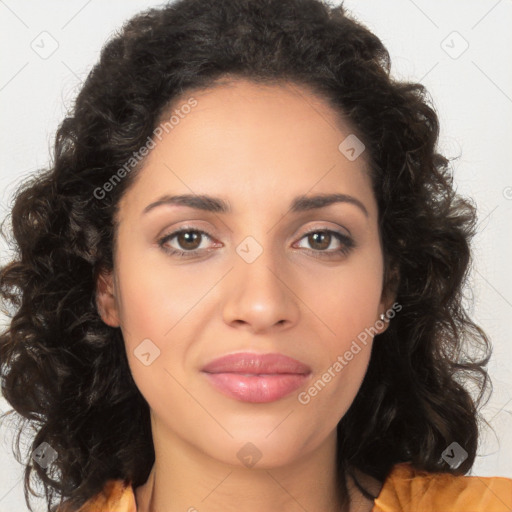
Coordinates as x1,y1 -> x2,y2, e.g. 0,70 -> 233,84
97,80 -> 393,512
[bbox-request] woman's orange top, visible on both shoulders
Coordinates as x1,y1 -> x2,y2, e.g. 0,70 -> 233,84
58,462 -> 512,512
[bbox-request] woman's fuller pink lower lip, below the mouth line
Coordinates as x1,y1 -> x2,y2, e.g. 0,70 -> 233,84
203,372 -> 309,403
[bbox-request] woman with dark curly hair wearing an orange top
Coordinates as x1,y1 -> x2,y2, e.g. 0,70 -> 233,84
0,0 -> 512,512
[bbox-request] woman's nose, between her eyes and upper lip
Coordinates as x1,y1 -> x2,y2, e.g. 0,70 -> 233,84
223,251 -> 300,334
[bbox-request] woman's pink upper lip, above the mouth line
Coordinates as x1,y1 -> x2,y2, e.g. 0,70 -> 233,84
202,352 -> 311,374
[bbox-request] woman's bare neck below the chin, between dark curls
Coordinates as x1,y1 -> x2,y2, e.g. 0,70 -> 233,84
135,418 -> 373,512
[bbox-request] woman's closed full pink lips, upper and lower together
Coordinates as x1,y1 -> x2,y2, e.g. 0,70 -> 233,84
201,352 -> 311,403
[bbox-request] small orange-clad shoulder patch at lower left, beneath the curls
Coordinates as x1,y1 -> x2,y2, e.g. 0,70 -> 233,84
55,479 -> 137,512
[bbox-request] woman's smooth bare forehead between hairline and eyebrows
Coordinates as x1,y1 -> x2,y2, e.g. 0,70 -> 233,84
120,80 -> 375,219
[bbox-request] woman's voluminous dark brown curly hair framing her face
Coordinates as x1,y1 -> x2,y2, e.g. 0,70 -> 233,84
0,0 -> 492,511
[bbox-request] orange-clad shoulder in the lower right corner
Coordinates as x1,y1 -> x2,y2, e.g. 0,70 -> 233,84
372,463 -> 512,512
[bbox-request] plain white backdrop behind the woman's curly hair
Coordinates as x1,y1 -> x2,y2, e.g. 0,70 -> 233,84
0,0 -> 512,512
